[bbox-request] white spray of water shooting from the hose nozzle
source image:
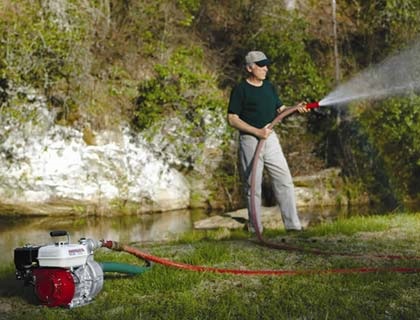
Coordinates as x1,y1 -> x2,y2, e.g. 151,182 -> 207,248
319,42 -> 420,106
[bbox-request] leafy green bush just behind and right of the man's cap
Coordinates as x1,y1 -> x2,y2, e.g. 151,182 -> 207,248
248,9 -> 327,104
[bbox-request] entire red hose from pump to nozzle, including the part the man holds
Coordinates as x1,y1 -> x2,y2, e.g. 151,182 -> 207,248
102,102 -> 420,276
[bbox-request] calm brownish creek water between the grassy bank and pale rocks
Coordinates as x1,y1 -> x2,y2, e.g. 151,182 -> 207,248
0,206 -> 420,264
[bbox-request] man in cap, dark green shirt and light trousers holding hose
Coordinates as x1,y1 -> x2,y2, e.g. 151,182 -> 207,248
228,51 -> 309,233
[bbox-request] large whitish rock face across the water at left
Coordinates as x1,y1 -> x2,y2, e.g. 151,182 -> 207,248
0,89 -> 190,213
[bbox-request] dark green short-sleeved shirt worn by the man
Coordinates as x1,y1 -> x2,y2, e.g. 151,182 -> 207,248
228,80 -> 283,128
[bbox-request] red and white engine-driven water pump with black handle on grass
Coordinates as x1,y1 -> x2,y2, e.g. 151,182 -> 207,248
14,231 -> 104,308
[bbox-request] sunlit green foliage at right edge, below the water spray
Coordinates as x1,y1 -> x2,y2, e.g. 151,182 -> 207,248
360,96 -> 420,197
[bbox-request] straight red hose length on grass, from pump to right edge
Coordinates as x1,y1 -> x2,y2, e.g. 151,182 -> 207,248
102,240 -> 420,276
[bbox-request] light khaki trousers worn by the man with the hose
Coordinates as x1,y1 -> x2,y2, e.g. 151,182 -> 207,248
239,132 -> 302,232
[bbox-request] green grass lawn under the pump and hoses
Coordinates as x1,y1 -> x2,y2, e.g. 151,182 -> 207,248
0,213 -> 420,320
